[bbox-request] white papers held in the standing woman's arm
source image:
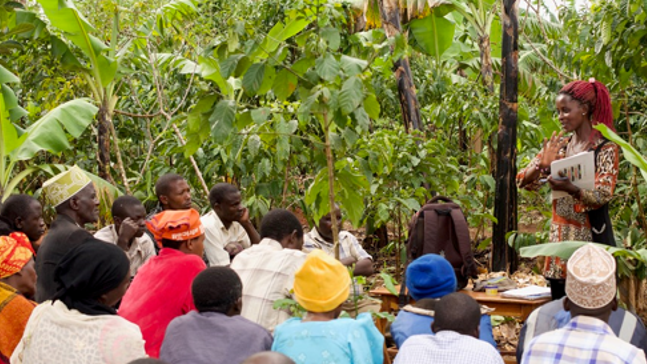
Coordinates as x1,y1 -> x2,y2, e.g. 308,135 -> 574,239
550,152 -> 595,200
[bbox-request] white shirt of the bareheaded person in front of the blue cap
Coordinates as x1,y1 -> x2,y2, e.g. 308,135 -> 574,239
394,330 -> 503,364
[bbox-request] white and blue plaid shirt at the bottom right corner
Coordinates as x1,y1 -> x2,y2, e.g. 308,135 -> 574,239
522,316 -> 647,364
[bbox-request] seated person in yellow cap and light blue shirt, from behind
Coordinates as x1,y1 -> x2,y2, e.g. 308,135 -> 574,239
272,250 -> 384,364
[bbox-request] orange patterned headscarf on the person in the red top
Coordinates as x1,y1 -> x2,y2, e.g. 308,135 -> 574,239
146,209 -> 204,243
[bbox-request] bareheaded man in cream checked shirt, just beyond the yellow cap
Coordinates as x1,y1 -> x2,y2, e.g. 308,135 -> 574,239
231,209 -> 306,331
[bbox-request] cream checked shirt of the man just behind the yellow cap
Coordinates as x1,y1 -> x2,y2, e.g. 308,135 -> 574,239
231,238 -> 306,331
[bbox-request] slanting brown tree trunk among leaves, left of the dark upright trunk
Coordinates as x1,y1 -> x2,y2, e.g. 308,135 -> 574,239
379,0 -> 422,132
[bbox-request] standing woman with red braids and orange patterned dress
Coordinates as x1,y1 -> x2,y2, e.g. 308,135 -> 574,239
517,78 -> 618,279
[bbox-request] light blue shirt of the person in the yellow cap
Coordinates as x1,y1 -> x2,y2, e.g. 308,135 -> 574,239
272,313 -> 384,364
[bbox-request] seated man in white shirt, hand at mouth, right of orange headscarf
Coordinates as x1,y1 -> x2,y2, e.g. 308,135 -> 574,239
200,183 -> 261,267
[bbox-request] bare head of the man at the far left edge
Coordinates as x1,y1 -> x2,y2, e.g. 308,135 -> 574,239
0,195 -> 45,251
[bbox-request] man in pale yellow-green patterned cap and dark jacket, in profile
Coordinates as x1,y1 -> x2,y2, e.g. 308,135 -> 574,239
36,166 -> 99,303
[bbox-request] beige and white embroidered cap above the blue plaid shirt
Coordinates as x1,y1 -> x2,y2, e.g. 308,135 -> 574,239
566,244 -> 616,309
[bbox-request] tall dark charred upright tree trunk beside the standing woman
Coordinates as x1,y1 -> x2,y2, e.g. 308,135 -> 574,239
492,0 -> 519,272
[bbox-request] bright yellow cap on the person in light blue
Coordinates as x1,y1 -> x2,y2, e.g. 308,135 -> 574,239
294,249 -> 350,312
